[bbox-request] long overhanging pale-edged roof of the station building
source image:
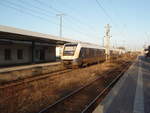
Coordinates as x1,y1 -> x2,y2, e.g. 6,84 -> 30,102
0,25 -> 77,45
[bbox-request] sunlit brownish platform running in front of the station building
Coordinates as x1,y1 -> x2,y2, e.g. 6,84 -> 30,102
0,61 -> 64,85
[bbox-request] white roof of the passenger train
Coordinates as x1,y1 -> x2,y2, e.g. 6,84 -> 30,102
64,42 -> 105,49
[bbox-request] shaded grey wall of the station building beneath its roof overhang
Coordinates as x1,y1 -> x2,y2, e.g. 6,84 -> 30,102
0,44 -> 56,66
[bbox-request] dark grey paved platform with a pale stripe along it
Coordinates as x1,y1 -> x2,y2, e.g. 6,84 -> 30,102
93,56 -> 150,113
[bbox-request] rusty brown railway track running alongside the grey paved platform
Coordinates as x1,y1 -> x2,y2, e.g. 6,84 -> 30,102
39,63 -> 129,113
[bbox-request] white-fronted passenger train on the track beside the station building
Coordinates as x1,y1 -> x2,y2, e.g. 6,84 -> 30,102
61,43 -> 123,68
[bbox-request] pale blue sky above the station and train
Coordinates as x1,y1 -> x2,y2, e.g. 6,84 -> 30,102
0,0 -> 150,50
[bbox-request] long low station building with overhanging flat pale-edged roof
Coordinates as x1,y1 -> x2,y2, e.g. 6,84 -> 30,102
0,26 -> 74,66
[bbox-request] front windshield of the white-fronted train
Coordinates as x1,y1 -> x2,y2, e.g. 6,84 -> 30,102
63,45 -> 77,56
